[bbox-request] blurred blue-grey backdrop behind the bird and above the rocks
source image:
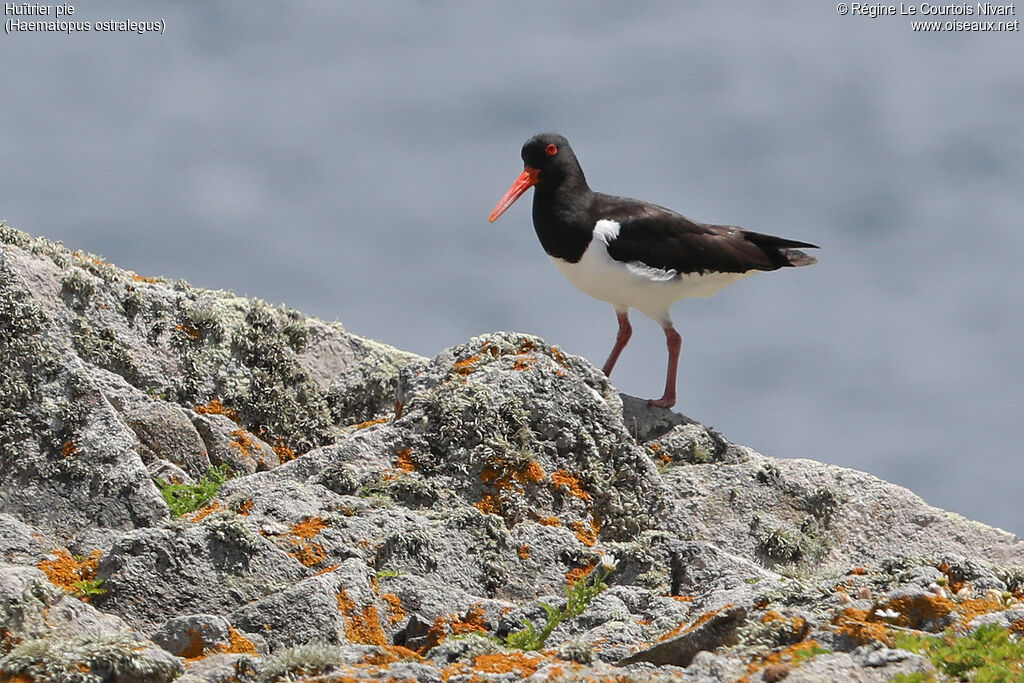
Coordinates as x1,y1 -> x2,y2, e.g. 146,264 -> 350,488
0,0 -> 1024,533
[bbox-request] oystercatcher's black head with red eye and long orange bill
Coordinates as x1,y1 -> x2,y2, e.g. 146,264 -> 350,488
490,133 -> 590,222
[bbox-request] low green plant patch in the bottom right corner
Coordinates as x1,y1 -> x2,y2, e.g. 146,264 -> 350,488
893,624 -> 1024,683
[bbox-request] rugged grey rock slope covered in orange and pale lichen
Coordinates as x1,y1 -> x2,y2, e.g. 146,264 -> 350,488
0,224 -> 1024,683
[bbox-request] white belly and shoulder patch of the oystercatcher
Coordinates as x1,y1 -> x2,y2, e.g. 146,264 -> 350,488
551,229 -> 757,323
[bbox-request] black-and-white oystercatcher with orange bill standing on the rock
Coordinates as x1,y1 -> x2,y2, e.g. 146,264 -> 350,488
490,133 -> 817,408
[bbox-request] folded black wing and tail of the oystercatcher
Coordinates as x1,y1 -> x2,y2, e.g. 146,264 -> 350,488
591,194 -> 817,273
